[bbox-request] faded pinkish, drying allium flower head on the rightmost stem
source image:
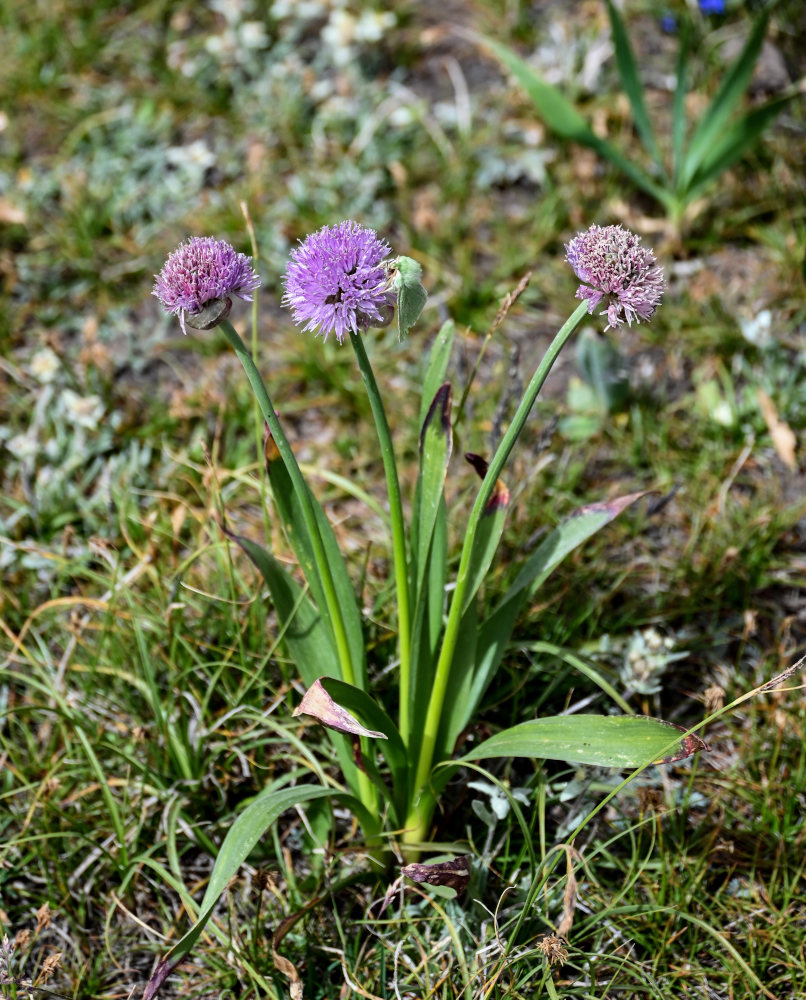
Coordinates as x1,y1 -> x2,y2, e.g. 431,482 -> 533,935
565,226 -> 665,330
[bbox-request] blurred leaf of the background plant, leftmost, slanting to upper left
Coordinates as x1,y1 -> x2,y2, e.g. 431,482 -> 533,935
483,38 -> 672,205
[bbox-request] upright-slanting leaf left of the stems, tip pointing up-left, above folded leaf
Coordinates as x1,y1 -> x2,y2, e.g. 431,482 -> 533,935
224,528 -> 340,687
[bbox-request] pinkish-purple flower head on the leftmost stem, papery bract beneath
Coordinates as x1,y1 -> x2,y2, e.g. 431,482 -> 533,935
152,236 -> 260,333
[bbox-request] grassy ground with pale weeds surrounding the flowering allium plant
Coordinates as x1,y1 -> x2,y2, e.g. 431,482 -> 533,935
0,0 -> 806,1000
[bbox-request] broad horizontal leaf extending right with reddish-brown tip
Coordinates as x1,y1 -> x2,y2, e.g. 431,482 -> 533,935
459,715 -> 708,768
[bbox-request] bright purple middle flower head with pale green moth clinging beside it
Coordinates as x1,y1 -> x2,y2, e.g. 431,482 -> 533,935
283,221 -> 395,343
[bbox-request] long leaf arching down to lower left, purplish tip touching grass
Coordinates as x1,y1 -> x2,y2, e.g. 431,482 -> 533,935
143,782 -> 373,1000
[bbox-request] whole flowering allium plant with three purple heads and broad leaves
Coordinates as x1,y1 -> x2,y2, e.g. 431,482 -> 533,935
144,222 -> 704,1000
